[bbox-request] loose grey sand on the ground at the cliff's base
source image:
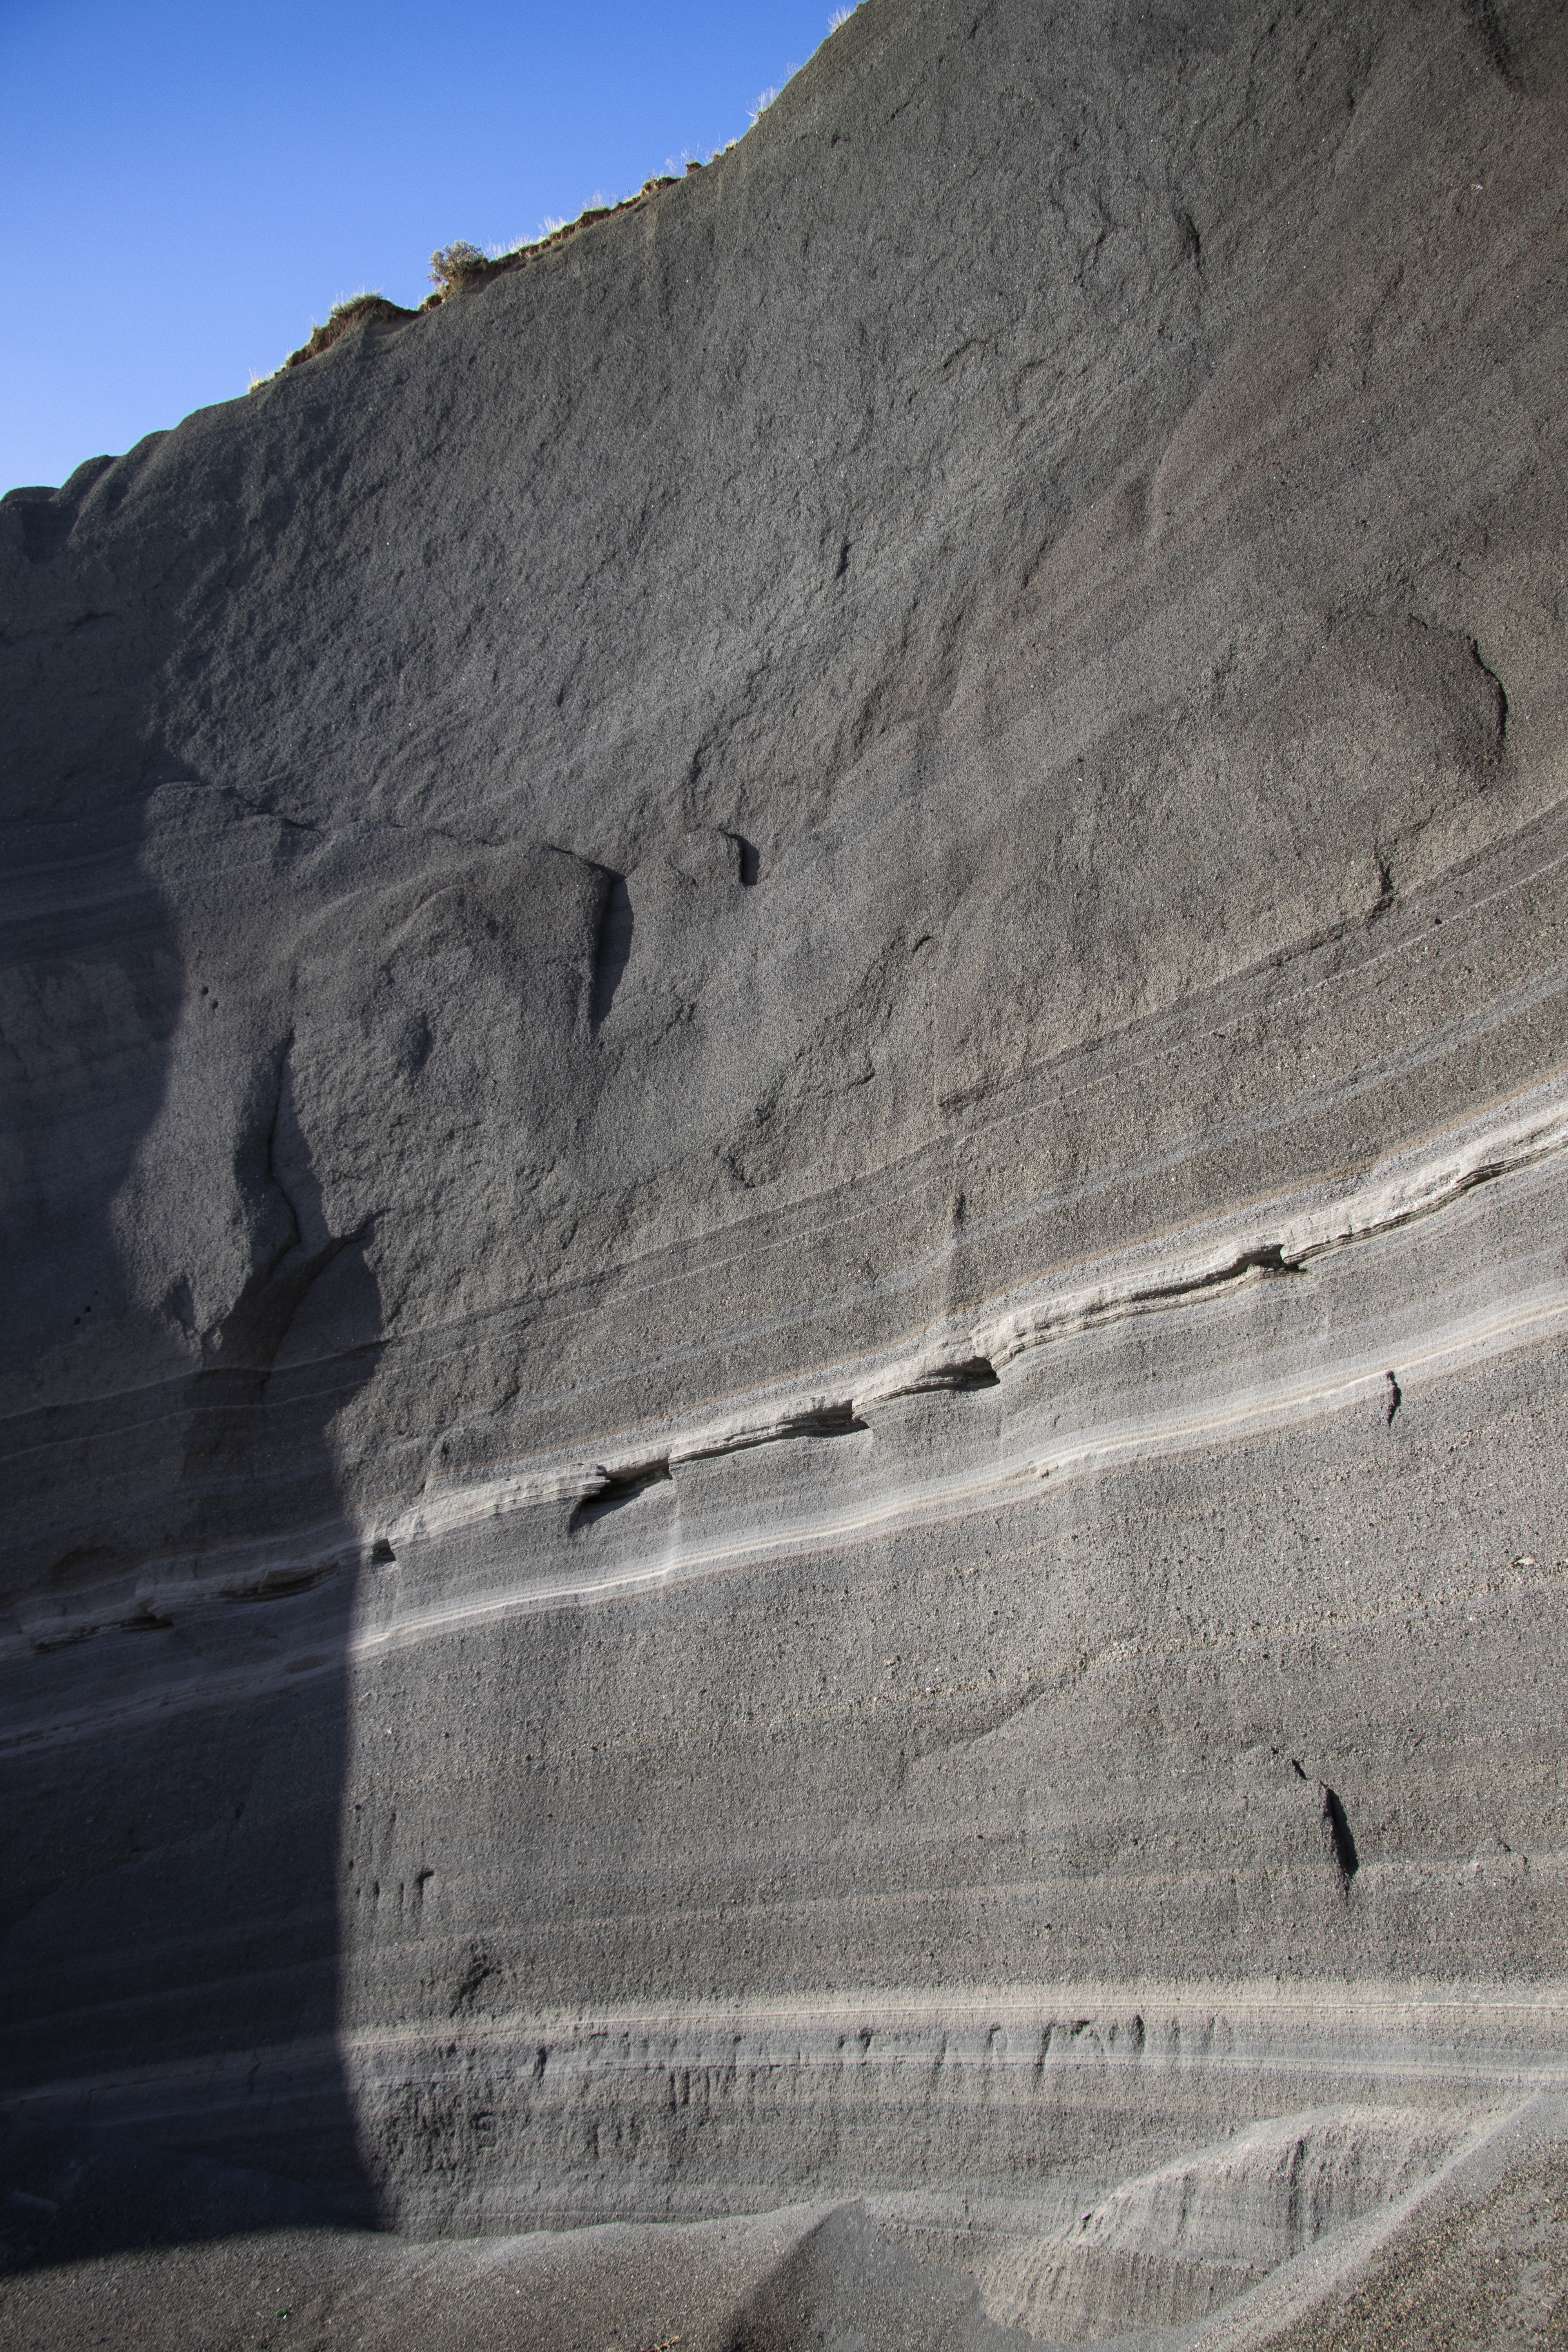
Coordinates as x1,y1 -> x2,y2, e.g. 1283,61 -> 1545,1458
7,2100 -> 1568,2352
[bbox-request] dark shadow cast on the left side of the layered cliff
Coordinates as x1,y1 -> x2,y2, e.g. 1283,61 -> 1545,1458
0,734 -> 379,2270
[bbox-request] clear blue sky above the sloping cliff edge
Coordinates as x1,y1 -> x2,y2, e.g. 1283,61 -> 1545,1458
0,0 -> 835,489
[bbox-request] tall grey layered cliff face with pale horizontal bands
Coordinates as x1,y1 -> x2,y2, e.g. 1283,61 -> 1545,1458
0,0 -> 1568,2343
